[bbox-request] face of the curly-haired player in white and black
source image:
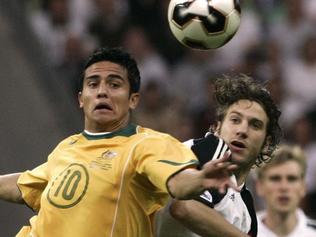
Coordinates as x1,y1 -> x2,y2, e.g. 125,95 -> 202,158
217,100 -> 268,170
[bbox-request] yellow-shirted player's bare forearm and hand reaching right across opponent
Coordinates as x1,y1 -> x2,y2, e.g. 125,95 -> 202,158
167,153 -> 237,199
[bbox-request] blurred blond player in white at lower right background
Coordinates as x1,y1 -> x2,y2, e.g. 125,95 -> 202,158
257,145 -> 316,237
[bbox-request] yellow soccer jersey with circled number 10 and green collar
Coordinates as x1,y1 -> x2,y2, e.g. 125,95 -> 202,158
17,124 -> 197,237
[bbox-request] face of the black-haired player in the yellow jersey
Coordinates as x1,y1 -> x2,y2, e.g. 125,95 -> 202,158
78,61 -> 139,132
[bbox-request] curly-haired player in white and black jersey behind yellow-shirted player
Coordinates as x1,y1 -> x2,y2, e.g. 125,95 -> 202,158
157,75 -> 281,237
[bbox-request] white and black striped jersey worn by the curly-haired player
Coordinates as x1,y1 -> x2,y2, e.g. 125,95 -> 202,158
184,133 -> 257,237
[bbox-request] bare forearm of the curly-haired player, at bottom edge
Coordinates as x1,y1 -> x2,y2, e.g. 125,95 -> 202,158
170,200 -> 249,237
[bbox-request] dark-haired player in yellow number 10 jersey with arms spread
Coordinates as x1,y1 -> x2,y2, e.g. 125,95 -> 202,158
0,48 -> 236,237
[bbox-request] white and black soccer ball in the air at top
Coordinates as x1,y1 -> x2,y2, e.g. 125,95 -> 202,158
168,0 -> 241,50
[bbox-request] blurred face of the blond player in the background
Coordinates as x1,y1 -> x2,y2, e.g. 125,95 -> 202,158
257,161 -> 305,214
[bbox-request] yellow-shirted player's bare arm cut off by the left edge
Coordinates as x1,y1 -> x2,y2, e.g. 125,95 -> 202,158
0,173 -> 24,203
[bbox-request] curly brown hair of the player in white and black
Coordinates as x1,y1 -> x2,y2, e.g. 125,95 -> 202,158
211,74 -> 282,166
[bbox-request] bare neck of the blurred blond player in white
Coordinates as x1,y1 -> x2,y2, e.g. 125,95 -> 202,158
263,210 -> 298,236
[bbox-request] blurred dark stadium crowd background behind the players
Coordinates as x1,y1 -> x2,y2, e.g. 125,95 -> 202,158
0,0 -> 316,236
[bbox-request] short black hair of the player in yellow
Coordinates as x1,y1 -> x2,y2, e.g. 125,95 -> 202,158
78,47 -> 140,93
